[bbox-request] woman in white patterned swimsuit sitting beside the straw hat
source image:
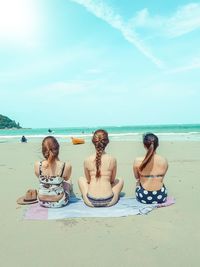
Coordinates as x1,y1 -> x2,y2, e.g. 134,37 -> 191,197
35,136 -> 71,208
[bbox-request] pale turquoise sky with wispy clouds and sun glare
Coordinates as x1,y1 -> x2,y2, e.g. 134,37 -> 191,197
0,0 -> 200,128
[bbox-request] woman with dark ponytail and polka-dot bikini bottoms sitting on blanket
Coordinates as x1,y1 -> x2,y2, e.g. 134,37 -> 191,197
133,133 -> 168,204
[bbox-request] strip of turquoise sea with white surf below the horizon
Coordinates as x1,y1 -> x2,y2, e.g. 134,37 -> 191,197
0,124 -> 200,143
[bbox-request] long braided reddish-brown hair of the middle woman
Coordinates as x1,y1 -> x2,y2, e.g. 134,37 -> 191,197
92,129 -> 109,178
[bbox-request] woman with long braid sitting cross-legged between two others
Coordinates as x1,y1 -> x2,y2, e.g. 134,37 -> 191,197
78,130 -> 124,207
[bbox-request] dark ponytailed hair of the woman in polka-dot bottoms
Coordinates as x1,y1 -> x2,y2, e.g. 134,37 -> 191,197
139,133 -> 159,171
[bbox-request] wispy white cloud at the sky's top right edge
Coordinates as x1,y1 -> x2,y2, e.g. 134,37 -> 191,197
130,3 -> 200,38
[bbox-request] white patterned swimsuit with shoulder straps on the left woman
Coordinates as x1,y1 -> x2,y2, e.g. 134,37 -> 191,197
38,162 -> 69,208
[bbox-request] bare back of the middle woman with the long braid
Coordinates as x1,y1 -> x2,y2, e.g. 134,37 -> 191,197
84,153 -> 117,198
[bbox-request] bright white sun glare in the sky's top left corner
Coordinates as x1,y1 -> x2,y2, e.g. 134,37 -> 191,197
0,0 -> 38,45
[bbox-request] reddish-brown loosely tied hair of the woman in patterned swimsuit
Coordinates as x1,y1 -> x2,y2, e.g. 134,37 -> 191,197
42,136 -> 60,164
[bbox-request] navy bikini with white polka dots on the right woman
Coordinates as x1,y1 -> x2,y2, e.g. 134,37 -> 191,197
135,175 -> 167,204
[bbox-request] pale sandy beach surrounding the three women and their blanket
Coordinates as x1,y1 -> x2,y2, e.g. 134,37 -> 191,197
0,141 -> 200,267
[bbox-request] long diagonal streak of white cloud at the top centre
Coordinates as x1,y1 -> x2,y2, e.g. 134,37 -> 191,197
71,0 -> 163,67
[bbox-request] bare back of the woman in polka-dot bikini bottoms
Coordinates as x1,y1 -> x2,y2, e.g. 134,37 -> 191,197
133,154 -> 168,191
